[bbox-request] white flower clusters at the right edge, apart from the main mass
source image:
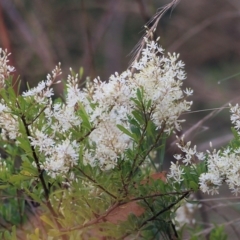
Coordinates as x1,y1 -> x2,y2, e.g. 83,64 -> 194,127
168,105 -> 240,195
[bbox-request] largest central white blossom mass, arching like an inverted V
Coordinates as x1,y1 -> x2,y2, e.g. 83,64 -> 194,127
81,40 -> 192,169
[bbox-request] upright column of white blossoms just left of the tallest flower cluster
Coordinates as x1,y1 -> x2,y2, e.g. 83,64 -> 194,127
84,71 -> 133,170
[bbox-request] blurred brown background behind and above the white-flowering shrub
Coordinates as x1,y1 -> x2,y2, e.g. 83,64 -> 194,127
0,0 -> 240,239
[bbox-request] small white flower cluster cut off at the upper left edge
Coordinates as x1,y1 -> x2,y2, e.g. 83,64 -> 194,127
0,48 -> 14,89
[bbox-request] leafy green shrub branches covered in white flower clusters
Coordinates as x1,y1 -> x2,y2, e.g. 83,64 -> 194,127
0,32 -> 236,239
